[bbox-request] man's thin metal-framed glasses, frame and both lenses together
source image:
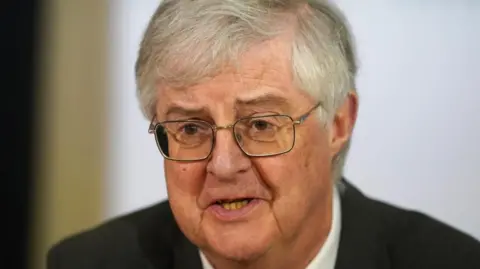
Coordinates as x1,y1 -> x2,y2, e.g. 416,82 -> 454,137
148,103 -> 321,161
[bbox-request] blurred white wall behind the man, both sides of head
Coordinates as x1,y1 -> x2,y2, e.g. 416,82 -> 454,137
105,0 -> 480,239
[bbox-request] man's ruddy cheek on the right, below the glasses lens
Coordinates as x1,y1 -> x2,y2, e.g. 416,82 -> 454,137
249,130 -> 331,228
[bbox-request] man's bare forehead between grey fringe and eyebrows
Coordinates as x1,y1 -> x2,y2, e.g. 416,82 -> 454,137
157,36 -> 308,114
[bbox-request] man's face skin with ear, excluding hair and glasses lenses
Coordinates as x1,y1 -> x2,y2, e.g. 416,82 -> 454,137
157,35 -> 354,261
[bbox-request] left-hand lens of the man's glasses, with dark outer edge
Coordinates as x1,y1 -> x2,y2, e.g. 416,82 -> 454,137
155,120 -> 213,161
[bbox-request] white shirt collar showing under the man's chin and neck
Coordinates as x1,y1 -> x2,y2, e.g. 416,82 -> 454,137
200,188 -> 342,269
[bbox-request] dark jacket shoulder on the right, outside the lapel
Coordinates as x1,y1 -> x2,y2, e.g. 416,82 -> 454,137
371,194 -> 480,269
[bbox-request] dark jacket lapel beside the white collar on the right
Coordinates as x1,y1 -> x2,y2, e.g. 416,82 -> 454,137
335,181 -> 390,269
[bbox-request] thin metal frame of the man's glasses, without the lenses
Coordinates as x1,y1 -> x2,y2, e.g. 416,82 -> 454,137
148,102 -> 322,162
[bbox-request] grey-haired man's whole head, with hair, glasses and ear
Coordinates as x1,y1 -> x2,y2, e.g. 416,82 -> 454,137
136,0 -> 358,264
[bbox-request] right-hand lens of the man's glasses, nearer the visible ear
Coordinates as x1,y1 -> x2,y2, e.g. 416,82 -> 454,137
234,115 -> 295,156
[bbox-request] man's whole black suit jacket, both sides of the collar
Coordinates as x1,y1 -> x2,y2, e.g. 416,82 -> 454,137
47,182 -> 480,269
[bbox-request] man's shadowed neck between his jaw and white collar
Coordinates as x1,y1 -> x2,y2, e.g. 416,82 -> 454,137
205,187 -> 333,269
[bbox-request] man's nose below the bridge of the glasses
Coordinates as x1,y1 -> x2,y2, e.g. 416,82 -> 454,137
207,125 -> 251,180
